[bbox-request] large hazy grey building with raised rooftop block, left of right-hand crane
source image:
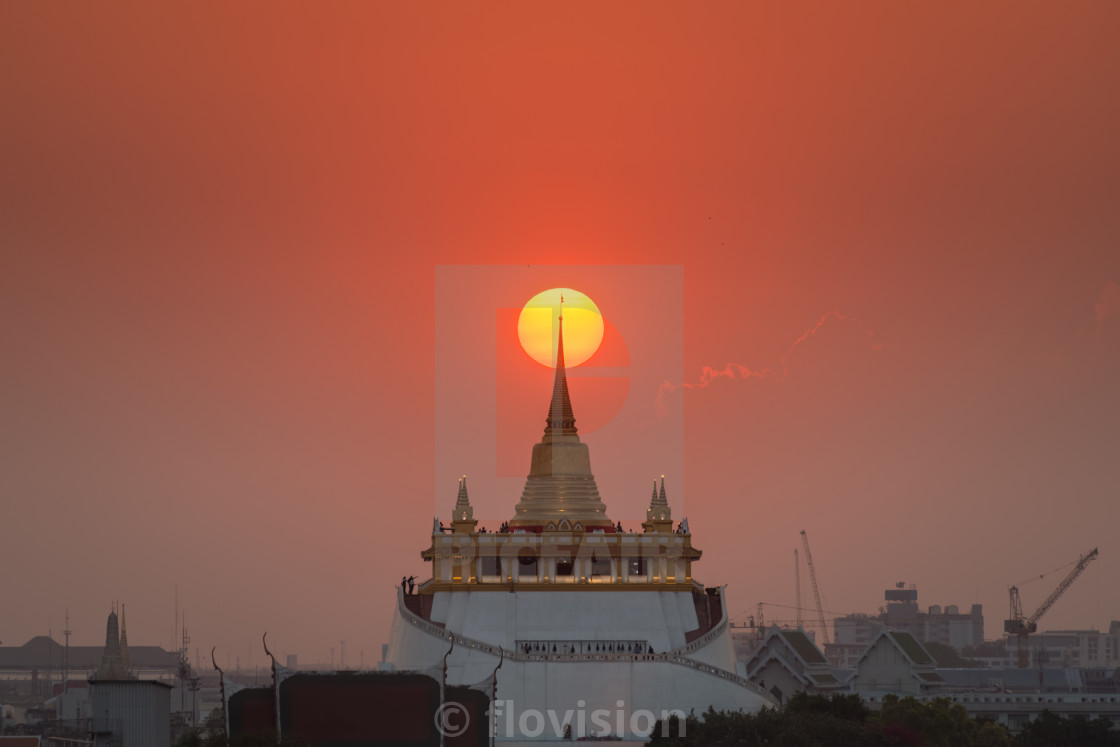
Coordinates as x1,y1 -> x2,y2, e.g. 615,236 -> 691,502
824,582 -> 983,666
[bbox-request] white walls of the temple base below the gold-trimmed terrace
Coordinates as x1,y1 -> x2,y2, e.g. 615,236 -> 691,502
386,591 -> 774,744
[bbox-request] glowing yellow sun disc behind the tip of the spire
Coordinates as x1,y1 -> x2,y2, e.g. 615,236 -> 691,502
517,288 -> 603,366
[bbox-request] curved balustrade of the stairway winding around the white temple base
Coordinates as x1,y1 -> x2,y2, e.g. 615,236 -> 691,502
396,589 -> 781,707
